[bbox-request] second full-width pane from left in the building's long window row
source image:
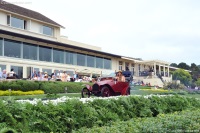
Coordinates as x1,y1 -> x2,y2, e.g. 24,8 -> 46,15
23,43 -> 38,60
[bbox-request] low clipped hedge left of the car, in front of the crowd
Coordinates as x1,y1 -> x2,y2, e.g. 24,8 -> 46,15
0,80 -> 92,93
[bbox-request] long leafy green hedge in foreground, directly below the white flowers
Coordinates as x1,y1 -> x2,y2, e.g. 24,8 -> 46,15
0,96 -> 200,133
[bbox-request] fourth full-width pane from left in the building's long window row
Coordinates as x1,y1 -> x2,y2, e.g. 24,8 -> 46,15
53,49 -> 64,63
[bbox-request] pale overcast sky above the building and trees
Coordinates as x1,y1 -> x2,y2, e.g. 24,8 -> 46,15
5,0 -> 200,65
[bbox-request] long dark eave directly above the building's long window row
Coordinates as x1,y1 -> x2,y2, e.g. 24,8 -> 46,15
0,29 -> 122,58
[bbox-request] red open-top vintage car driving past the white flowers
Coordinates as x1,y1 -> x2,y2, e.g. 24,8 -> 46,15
81,76 -> 130,98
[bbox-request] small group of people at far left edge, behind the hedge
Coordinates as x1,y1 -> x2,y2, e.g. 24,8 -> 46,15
0,68 -> 18,79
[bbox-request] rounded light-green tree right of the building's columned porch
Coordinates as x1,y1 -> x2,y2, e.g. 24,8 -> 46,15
173,69 -> 192,86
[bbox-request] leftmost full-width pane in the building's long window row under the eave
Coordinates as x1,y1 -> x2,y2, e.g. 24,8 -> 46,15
4,40 -> 21,58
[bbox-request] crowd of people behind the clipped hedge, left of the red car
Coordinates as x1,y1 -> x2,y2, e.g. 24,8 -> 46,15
31,70 -> 78,81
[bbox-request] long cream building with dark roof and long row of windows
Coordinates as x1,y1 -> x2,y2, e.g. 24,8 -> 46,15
0,0 -> 172,85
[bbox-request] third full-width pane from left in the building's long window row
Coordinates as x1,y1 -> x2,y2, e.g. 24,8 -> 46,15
39,46 -> 52,62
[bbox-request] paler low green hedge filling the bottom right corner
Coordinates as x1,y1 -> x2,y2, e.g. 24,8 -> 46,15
73,109 -> 200,133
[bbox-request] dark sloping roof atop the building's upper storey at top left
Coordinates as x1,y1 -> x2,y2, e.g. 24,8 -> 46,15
0,0 -> 64,28
